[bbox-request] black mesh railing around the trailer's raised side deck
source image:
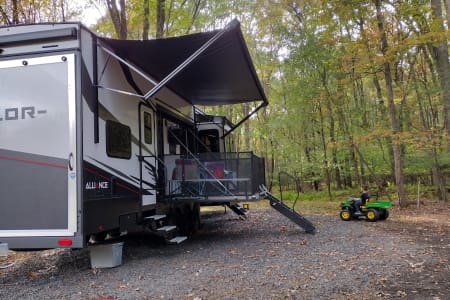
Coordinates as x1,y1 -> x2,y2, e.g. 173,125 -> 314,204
164,152 -> 265,202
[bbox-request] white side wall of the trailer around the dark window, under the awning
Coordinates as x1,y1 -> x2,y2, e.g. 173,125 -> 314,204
82,38 -> 193,206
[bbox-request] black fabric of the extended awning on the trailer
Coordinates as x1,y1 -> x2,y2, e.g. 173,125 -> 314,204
100,21 -> 267,106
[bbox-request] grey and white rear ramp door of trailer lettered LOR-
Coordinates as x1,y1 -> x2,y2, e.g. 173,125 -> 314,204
0,54 -> 77,248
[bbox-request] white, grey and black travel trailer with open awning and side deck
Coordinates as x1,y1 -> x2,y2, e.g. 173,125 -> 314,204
0,21 -> 314,254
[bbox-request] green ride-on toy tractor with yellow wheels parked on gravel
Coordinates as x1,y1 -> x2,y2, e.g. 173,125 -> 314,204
339,197 -> 392,222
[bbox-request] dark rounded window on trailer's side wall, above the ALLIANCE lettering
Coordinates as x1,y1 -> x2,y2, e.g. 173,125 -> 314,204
106,120 -> 131,159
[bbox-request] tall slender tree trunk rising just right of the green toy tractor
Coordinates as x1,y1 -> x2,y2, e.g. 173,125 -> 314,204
375,0 -> 407,207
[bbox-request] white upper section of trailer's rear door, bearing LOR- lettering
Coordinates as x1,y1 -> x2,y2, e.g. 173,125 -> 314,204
0,55 -> 74,159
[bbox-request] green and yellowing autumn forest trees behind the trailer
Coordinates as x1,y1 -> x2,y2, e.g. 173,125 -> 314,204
0,0 -> 450,205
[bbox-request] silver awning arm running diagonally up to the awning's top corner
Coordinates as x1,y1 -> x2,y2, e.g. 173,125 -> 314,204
144,20 -> 239,101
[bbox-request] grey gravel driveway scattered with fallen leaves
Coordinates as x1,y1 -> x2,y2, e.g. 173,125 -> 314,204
0,207 -> 444,300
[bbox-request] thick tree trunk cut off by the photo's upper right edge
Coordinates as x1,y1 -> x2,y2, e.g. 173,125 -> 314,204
431,0 -> 450,142
